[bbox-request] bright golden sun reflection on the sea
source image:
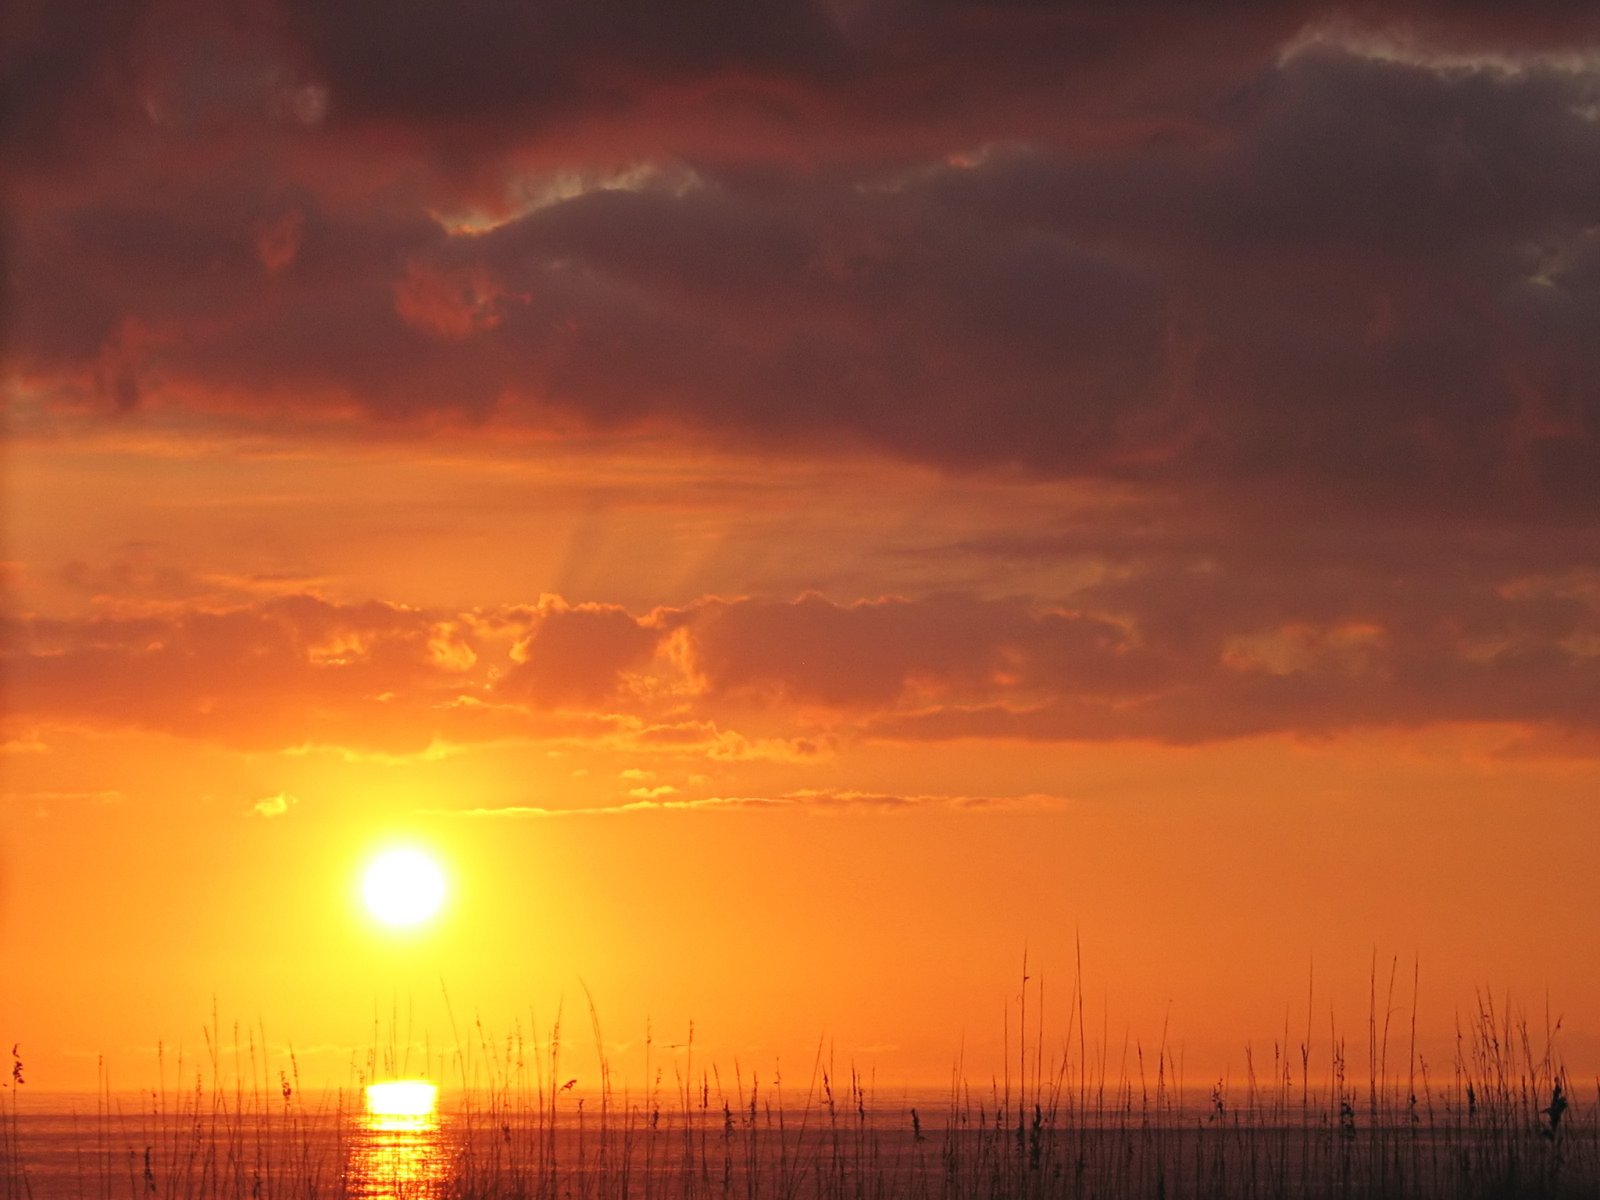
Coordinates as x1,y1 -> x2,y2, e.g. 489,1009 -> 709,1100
347,1080 -> 446,1200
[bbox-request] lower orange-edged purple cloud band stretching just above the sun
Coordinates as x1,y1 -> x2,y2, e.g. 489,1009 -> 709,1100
6,570 -> 1600,755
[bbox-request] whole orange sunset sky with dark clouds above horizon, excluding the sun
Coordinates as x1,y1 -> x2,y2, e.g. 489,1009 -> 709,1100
0,0 -> 1600,1088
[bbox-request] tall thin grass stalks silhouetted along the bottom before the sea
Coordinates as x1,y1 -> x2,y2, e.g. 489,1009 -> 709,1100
0,963 -> 1600,1200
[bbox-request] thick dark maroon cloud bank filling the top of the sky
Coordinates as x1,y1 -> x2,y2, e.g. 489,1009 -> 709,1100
10,3 -> 1600,514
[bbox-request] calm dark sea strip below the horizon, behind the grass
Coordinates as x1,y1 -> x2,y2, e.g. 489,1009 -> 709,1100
0,1090 -> 1574,1200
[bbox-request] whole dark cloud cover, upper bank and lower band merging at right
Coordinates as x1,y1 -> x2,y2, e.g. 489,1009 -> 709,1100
3,0 -> 1600,771
